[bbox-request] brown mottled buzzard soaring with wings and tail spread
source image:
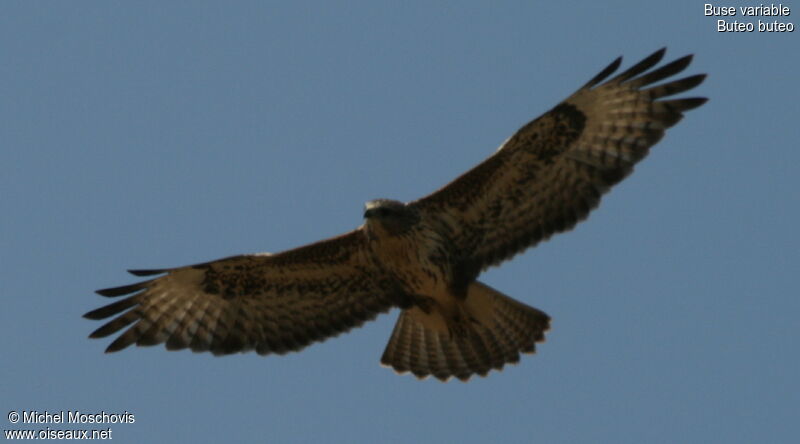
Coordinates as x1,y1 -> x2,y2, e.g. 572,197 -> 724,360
84,49 -> 707,381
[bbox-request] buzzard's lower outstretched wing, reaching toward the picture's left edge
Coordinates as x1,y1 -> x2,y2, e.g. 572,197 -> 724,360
84,229 -> 395,354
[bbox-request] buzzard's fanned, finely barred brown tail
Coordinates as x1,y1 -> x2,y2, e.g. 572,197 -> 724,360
381,282 -> 550,381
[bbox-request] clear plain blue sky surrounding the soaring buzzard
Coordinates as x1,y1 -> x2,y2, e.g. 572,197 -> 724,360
0,1 -> 800,443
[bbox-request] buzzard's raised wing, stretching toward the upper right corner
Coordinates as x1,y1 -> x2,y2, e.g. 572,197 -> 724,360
410,49 -> 706,272
